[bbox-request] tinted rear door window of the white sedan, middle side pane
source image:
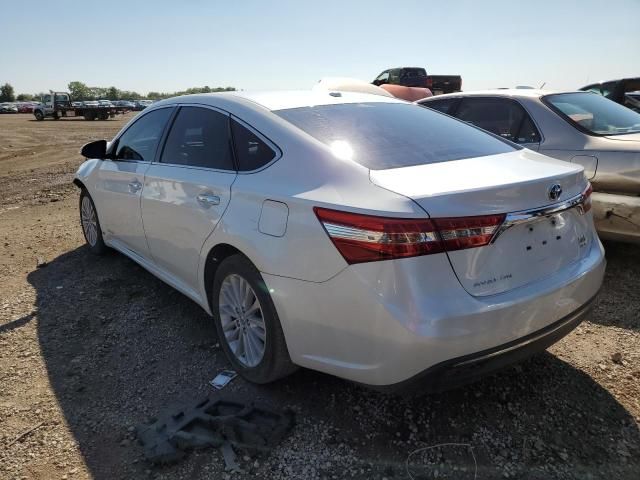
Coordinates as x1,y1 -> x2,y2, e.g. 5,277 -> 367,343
160,107 -> 234,170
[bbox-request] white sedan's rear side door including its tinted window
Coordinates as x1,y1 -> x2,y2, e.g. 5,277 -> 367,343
142,105 -> 237,290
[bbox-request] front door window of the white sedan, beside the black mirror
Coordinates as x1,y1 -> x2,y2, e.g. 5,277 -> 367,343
115,108 -> 173,162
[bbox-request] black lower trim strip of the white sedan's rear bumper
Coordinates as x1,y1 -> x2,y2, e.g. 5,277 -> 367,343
374,297 -> 595,395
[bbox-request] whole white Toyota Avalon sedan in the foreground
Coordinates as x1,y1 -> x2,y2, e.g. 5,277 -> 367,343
74,91 -> 605,391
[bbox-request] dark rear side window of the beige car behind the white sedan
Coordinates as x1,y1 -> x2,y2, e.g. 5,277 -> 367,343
455,98 -> 540,143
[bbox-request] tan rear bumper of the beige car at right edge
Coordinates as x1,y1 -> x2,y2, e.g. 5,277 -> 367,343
592,192 -> 640,244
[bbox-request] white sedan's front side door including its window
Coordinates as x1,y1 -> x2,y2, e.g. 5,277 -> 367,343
95,108 -> 173,258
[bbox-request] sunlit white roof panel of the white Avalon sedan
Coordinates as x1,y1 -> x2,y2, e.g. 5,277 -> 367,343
159,90 -> 407,110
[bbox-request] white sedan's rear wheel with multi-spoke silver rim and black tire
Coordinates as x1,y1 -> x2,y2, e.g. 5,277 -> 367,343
211,254 -> 297,384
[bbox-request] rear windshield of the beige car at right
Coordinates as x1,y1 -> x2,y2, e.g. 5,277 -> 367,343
544,92 -> 640,135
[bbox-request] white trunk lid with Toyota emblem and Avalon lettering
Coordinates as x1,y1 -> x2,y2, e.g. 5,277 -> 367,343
370,149 -> 593,296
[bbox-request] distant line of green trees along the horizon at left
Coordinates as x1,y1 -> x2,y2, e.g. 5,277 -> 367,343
0,82 -> 235,102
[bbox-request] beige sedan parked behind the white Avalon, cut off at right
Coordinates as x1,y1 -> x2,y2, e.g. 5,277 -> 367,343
418,89 -> 640,243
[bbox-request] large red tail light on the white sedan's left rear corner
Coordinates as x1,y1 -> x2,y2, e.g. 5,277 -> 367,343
314,207 -> 505,264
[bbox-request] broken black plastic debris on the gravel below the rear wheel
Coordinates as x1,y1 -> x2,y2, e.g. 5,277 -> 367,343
136,398 -> 294,464
